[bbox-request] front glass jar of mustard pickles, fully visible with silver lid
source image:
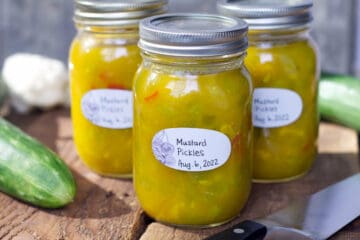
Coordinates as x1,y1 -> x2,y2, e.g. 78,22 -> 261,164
133,14 -> 252,227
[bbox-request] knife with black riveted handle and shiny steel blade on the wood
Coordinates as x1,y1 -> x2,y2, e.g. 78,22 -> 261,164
205,173 -> 360,240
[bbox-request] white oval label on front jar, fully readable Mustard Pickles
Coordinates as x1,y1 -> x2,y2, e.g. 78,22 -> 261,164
152,128 -> 231,172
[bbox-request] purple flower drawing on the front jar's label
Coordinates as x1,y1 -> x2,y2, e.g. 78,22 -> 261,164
152,131 -> 175,166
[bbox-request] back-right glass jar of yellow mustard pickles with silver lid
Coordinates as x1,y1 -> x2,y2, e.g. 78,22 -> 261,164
218,0 -> 319,182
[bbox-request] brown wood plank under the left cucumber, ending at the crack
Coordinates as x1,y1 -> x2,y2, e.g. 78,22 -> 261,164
0,109 -> 145,240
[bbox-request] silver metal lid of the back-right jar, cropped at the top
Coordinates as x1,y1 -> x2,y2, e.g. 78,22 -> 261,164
217,0 -> 313,30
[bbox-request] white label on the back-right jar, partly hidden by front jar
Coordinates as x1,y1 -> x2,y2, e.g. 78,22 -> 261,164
252,88 -> 303,128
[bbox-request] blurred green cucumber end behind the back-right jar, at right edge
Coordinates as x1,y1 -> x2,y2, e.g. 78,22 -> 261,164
319,73 -> 360,131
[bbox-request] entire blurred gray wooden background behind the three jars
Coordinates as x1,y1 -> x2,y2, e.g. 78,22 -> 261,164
0,0 -> 360,75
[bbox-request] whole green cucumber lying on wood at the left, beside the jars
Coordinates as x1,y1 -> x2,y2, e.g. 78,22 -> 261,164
0,118 -> 76,208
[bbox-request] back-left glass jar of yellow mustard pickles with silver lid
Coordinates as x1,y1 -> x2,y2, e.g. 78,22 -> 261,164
69,0 -> 166,177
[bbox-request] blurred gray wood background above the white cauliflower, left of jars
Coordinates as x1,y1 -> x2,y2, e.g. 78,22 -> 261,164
0,0 -> 75,66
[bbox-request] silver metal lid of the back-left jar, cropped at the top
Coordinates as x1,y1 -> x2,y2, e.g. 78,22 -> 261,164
74,0 -> 168,27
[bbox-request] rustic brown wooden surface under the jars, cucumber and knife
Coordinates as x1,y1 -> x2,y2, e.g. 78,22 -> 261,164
0,109 -> 360,240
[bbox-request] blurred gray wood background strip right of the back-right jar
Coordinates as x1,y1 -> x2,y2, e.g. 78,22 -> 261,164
312,0 -> 360,73
